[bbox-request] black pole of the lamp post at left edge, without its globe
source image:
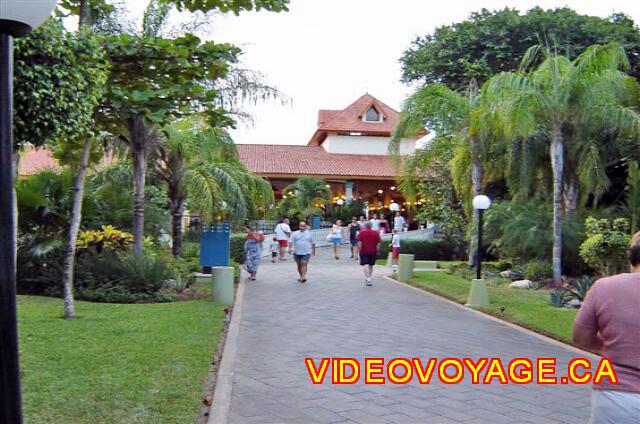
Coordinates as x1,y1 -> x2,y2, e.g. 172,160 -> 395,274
0,33 -> 22,424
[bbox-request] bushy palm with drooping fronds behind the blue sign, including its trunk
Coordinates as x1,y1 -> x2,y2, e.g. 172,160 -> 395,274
154,120 -> 273,257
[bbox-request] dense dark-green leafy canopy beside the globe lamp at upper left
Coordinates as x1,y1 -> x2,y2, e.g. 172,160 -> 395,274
14,19 -> 108,152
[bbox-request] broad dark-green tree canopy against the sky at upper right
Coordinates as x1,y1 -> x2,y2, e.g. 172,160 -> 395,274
400,7 -> 640,89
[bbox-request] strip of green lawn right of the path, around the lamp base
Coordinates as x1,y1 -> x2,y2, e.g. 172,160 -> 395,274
411,272 -> 578,343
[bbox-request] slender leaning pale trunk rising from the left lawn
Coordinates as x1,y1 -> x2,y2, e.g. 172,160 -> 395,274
62,137 -> 91,318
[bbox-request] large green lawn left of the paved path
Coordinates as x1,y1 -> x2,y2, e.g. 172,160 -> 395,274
18,296 -> 224,424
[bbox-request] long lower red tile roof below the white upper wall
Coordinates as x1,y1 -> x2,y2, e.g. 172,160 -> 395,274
237,144 -> 396,179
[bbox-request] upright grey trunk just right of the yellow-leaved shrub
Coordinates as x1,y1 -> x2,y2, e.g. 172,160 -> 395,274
128,117 -> 149,255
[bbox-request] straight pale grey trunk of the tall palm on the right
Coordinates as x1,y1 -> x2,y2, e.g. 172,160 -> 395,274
550,124 -> 564,287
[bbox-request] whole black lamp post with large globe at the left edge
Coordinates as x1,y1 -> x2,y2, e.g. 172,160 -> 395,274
0,0 -> 56,424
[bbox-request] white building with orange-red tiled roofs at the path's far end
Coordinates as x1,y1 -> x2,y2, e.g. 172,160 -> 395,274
238,94 -> 426,210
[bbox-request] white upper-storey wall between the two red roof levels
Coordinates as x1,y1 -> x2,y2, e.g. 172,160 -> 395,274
322,135 -> 416,155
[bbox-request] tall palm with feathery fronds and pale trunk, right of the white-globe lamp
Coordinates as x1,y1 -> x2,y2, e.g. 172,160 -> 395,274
483,43 -> 640,286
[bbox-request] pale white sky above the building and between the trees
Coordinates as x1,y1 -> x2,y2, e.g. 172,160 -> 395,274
121,0 -> 640,144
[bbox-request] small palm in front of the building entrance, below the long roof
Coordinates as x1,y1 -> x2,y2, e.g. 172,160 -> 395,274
280,175 -> 331,221
